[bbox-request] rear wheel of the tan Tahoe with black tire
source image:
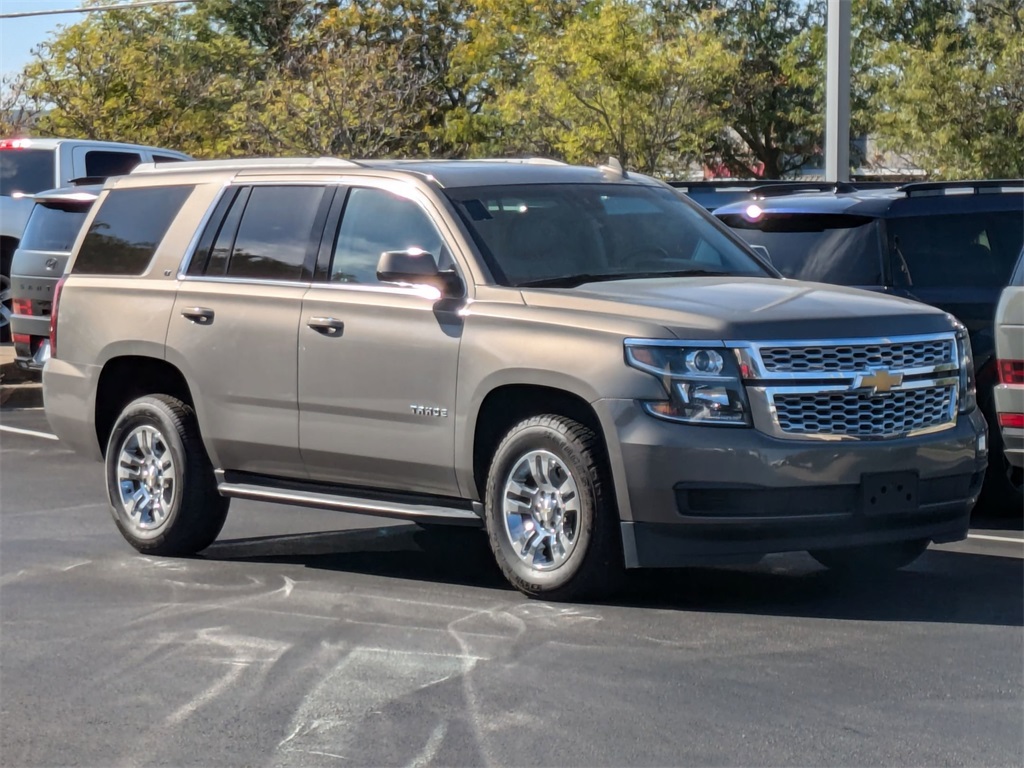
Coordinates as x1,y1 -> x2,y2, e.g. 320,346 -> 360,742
105,394 -> 230,557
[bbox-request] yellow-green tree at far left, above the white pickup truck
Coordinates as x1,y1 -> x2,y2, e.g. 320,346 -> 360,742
25,6 -> 253,157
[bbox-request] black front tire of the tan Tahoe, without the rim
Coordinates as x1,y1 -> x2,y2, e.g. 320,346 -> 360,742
484,415 -> 623,600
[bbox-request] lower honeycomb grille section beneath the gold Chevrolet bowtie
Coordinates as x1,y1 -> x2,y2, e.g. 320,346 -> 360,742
772,385 -> 956,437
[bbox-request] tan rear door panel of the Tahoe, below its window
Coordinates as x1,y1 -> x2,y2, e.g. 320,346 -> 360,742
167,280 -> 307,477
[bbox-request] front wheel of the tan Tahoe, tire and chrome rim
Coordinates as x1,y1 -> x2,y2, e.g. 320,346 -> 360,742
485,415 -> 622,600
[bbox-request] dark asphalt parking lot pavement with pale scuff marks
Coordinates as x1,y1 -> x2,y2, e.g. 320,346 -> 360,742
0,410 -> 1024,766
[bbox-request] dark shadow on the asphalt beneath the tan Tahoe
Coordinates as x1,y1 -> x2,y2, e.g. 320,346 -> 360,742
203,525 -> 1024,627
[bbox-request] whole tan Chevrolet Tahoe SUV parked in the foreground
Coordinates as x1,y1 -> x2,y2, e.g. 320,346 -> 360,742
43,159 -> 986,599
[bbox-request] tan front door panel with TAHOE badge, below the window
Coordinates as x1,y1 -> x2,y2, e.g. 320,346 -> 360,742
299,286 -> 462,496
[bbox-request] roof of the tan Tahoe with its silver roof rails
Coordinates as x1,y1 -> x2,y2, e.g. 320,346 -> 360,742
131,158 -> 658,188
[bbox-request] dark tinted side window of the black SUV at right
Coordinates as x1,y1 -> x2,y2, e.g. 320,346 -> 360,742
886,210 -> 1024,288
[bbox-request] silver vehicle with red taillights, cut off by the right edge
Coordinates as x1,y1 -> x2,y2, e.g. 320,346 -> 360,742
995,250 -> 1024,475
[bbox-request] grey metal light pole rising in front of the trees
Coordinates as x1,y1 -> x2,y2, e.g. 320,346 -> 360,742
825,0 -> 852,181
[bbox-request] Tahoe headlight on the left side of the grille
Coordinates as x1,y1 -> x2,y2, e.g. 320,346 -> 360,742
626,339 -> 751,426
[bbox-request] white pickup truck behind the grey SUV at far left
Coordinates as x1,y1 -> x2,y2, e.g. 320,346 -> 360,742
0,138 -> 189,341
